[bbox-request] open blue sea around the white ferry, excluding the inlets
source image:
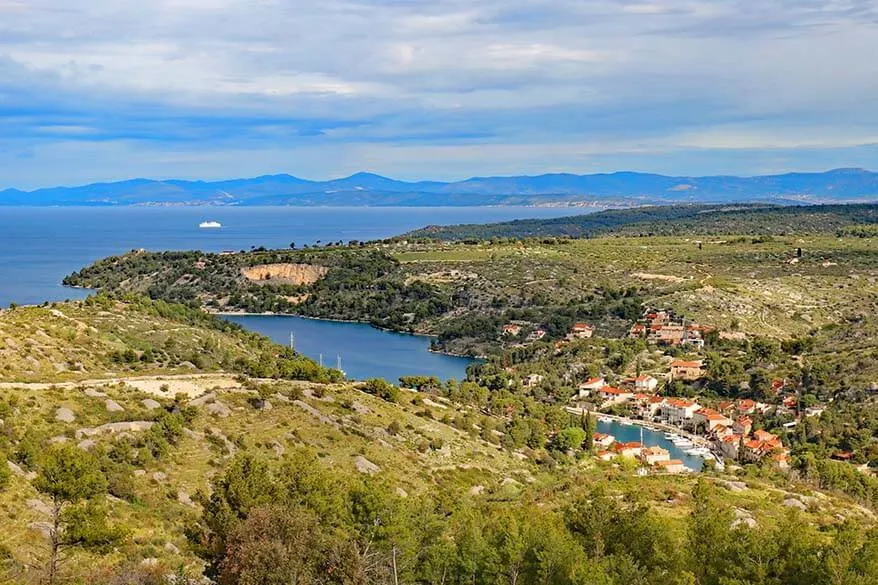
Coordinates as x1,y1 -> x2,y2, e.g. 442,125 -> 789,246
0,207 -> 576,306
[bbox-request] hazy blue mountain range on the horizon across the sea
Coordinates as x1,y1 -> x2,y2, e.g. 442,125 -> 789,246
0,169 -> 878,207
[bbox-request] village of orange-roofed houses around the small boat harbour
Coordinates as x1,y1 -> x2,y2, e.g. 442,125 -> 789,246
503,309 -> 825,473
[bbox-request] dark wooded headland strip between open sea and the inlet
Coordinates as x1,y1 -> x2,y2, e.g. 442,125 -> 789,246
64,244 -> 641,354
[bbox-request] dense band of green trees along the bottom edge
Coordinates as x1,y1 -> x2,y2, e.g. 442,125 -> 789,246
191,454 -> 878,585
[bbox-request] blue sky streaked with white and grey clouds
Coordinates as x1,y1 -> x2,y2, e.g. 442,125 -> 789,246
0,0 -> 878,189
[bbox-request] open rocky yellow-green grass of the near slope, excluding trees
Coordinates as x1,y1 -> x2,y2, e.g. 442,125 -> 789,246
0,304 -> 872,571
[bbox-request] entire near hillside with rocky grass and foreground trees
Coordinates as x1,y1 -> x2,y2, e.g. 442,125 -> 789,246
0,298 -> 878,585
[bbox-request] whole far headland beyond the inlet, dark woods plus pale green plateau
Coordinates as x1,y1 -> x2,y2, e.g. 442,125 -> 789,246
65,222 -> 878,355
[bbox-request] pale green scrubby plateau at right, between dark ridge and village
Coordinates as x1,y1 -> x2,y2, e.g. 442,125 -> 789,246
396,236 -> 878,337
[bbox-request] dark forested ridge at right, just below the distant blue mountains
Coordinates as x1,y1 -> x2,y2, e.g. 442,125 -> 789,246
401,204 -> 878,241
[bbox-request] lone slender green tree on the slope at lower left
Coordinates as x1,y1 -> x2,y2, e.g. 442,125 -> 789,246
33,443 -> 112,585
